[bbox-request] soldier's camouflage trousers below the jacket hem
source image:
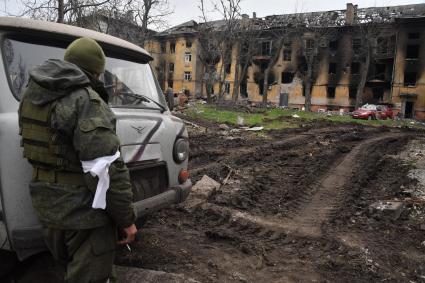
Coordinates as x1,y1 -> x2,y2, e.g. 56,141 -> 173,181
43,224 -> 117,283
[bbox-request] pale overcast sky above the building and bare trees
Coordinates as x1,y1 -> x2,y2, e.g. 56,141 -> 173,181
0,0 -> 425,29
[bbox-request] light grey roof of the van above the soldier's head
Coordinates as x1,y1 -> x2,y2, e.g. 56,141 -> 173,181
0,17 -> 153,61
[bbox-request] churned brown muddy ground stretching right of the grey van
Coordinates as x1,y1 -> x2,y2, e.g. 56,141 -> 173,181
4,117 -> 425,282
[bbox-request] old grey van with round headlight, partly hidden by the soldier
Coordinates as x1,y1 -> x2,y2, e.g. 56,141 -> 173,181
0,17 -> 192,261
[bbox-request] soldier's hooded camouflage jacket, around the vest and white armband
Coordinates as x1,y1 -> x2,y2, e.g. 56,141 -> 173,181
20,59 -> 134,229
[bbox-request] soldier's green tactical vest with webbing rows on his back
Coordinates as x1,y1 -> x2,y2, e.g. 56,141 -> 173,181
19,96 -> 82,175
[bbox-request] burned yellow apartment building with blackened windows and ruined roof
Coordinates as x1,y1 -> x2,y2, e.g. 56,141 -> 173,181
145,4 -> 425,120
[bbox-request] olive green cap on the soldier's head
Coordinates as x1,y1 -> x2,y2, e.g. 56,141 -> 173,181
64,37 -> 105,74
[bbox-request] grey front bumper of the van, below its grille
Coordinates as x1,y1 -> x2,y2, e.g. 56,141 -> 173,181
133,179 -> 192,218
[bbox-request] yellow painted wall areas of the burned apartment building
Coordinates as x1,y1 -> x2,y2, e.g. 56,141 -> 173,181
145,23 -> 425,119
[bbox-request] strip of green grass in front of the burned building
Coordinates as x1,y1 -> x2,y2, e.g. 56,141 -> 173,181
185,103 -> 425,130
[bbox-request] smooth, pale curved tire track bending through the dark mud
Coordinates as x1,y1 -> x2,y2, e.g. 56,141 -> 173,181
201,133 -> 400,238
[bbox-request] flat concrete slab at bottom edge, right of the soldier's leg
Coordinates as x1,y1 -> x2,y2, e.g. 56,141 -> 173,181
115,266 -> 199,283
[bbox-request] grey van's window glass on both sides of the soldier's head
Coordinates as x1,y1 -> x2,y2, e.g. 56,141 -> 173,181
2,39 -> 166,110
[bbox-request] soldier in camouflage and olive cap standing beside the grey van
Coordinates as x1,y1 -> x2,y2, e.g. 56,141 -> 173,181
19,38 -> 137,283
